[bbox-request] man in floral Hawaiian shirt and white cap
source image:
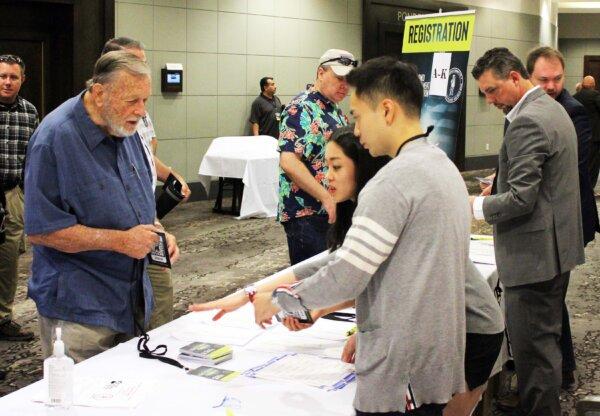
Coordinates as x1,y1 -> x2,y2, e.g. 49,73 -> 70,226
278,49 -> 357,264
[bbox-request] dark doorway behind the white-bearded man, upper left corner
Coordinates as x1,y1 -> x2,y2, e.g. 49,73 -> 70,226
0,0 -> 115,119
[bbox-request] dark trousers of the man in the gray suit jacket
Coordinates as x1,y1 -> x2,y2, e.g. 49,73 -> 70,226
505,273 -> 569,416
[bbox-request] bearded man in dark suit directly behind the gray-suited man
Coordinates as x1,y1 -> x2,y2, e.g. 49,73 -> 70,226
527,46 -> 600,388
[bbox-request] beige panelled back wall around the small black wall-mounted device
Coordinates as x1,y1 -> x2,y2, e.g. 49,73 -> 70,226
116,0 -> 362,181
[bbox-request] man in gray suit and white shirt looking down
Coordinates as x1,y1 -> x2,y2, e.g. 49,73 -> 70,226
471,48 -> 584,416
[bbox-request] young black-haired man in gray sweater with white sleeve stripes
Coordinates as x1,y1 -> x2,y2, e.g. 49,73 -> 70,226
254,57 -> 471,415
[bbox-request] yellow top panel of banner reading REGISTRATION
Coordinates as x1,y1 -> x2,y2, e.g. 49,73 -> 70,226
402,13 -> 475,53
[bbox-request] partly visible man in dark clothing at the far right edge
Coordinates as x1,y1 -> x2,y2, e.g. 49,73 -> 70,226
573,75 -> 600,188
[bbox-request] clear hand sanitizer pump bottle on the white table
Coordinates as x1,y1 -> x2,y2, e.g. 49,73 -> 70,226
44,328 -> 75,408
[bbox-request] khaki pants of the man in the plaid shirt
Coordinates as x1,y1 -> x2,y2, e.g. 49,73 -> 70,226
0,186 -> 25,321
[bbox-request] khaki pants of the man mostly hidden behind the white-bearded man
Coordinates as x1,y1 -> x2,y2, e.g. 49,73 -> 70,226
148,264 -> 173,330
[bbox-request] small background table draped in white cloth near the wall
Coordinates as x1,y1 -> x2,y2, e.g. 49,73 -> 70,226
198,136 -> 279,219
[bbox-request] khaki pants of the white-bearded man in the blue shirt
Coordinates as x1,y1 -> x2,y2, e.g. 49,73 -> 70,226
38,313 -> 132,363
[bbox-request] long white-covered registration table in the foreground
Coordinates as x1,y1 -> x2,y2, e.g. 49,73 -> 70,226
0,239 -> 504,416
